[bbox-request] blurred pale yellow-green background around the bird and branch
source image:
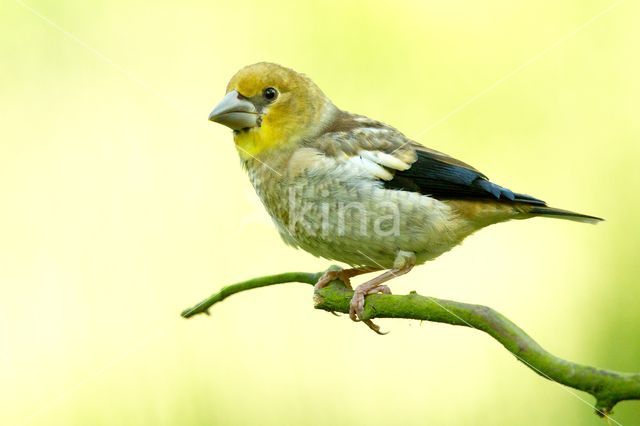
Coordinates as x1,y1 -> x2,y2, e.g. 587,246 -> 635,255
0,0 -> 640,426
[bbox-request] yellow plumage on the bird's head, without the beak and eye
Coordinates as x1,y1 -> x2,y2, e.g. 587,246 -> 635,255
227,62 -> 335,156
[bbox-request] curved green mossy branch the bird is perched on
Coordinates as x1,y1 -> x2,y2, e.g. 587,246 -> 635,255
182,272 -> 640,416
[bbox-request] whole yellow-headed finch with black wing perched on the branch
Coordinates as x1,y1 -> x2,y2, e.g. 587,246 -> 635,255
209,62 -> 603,334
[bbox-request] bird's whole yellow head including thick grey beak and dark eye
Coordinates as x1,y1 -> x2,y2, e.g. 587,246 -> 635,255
209,62 -> 335,156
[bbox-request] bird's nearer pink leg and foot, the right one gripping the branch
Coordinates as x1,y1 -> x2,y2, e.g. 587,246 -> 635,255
349,251 -> 416,334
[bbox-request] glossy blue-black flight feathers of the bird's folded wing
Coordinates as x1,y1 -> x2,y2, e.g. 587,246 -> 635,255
384,149 -> 546,206
